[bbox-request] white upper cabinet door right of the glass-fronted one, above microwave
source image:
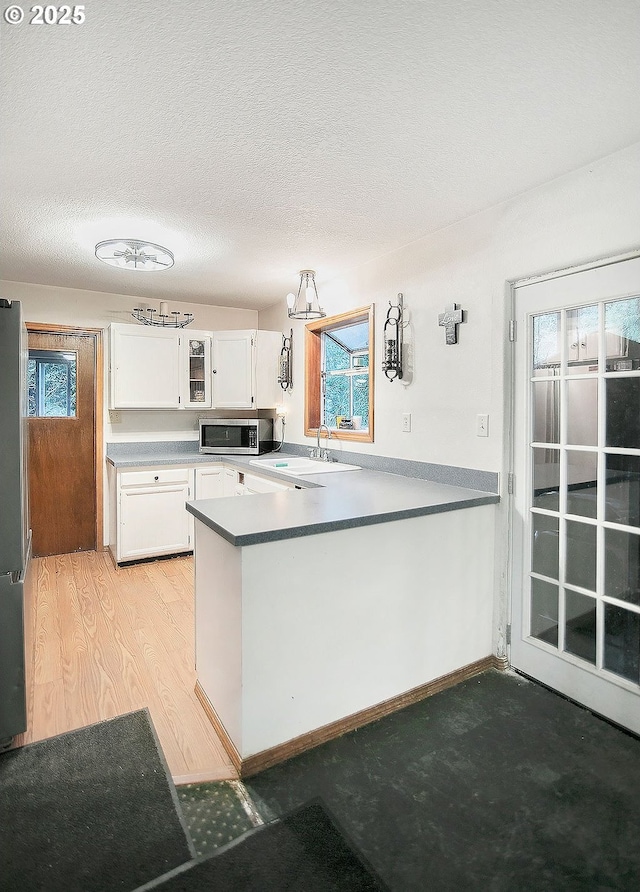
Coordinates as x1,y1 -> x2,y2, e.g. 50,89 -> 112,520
213,330 -> 255,409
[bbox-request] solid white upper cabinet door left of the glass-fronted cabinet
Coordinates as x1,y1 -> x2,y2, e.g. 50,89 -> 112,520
110,325 -> 180,409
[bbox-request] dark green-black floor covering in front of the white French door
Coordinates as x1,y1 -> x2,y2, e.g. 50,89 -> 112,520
245,671 -> 640,892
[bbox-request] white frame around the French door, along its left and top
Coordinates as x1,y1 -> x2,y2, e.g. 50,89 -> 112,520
508,248 -> 640,708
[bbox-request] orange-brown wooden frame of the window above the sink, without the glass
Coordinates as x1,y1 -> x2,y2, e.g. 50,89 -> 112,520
304,304 -> 375,443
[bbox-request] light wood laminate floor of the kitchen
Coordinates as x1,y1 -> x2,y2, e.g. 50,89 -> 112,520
15,551 -> 237,783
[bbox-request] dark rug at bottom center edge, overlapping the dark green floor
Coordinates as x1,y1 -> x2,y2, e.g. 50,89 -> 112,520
136,801 -> 386,892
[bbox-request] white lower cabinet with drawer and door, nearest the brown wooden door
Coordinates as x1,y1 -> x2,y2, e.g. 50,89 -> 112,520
116,468 -> 193,563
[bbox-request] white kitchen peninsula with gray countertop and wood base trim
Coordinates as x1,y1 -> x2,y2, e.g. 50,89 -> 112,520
187,456 -> 499,776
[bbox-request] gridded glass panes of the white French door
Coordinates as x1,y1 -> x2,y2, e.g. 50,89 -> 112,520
522,297 -> 640,691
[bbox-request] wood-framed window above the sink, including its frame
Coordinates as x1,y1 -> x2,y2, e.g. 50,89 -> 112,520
305,306 -> 373,443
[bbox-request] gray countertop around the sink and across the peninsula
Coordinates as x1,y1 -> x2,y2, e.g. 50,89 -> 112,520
107,442 -> 500,546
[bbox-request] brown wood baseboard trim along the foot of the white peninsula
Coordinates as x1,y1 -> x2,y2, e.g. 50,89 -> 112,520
195,654 -> 500,778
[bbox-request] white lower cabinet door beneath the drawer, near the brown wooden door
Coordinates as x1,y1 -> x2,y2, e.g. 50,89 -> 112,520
118,483 -> 192,561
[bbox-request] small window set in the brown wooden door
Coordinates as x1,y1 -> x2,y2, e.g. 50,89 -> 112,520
27,350 -> 77,418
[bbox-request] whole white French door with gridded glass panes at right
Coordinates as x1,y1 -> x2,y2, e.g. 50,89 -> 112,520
511,257 -> 640,733
